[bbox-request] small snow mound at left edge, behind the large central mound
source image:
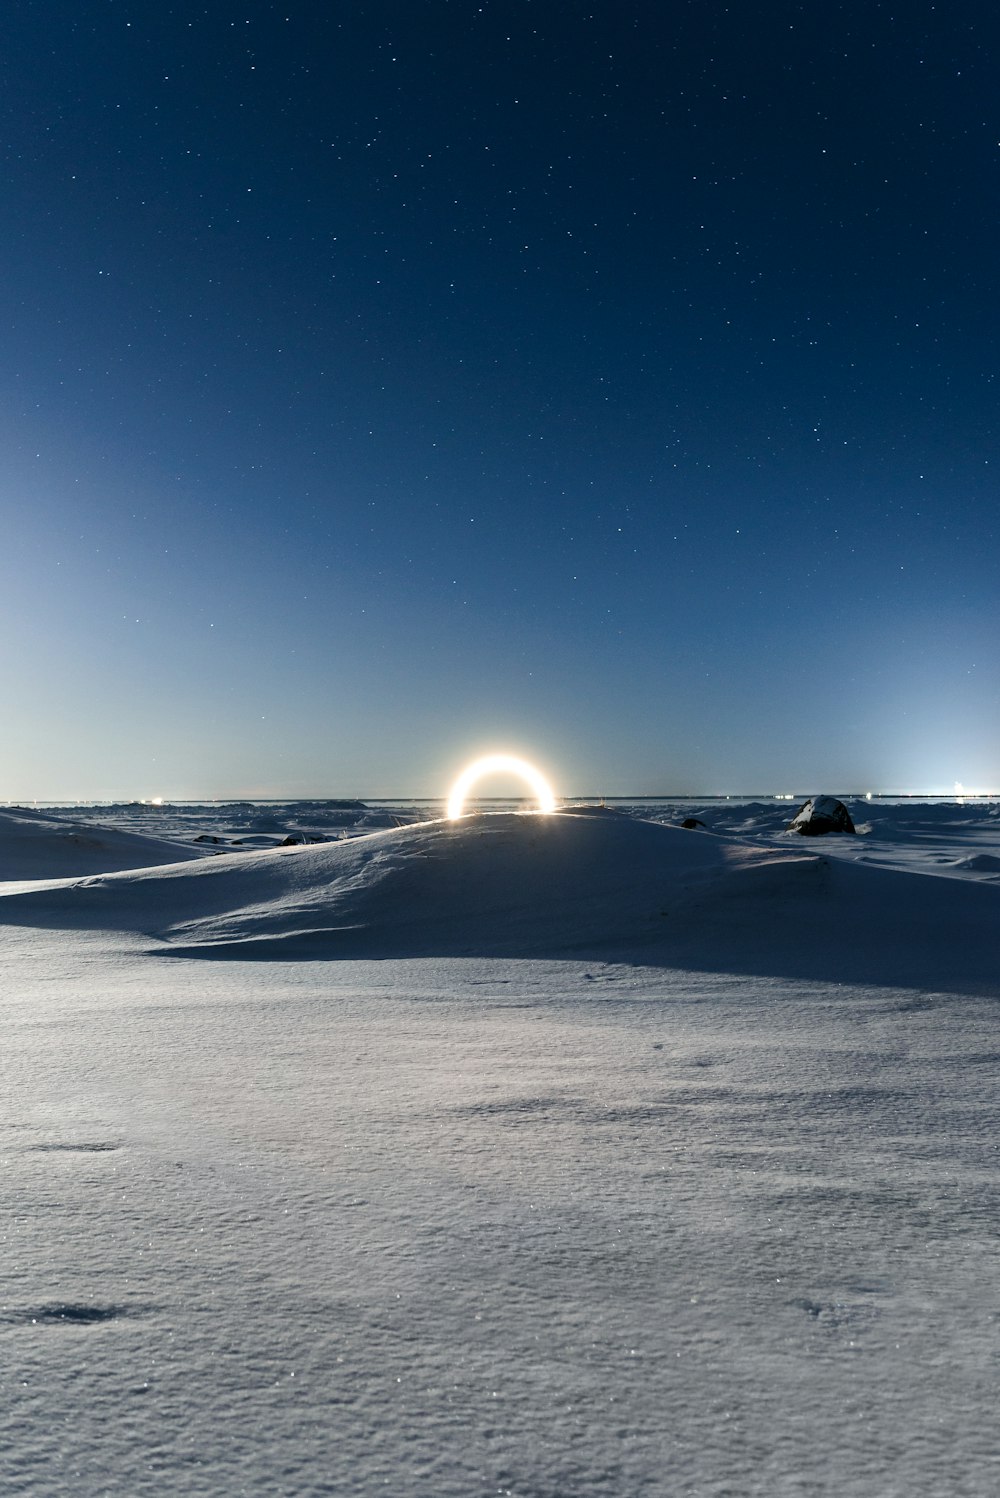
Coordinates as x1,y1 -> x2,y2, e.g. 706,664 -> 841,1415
0,807 -> 204,881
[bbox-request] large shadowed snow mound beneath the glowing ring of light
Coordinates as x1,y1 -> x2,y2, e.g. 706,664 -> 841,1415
0,809 -> 1000,992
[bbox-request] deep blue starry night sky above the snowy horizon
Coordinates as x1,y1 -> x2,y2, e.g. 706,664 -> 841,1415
0,0 -> 1000,798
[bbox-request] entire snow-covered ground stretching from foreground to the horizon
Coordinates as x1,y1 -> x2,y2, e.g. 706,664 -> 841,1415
0,801 -> 1000,1498
